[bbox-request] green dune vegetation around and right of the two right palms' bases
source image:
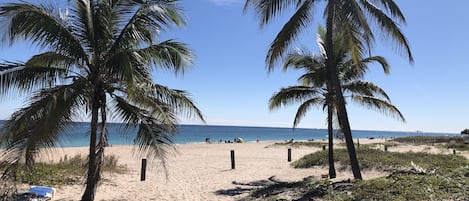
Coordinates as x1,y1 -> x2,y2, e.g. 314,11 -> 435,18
245,146 -> 469,201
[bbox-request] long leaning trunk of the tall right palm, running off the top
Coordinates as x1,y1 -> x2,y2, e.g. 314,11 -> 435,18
326,0 -> 362,179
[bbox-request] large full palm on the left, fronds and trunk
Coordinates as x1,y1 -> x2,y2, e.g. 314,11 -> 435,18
0,0 -> 203,201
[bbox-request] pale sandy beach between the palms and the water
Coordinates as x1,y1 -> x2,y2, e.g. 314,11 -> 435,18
18,139 -> 444,201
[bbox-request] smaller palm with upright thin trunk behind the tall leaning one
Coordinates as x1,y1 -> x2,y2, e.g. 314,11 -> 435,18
269,27 -> 405,178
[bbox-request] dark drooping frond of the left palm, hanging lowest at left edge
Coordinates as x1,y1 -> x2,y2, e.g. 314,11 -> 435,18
0,82 -> 86,169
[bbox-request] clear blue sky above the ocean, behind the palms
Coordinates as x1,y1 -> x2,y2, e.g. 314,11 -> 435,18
0,0 -> 469,133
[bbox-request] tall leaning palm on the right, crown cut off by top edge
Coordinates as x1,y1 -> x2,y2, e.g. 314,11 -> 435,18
244,0 -> 413,179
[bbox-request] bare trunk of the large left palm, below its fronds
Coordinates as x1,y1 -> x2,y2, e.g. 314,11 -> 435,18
81,88 -> 99,201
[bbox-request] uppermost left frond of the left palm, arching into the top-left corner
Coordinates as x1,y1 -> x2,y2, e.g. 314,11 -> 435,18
0,3 -> 87,62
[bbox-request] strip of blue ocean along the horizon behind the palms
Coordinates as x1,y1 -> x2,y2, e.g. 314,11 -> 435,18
42,122 -> 459,147
